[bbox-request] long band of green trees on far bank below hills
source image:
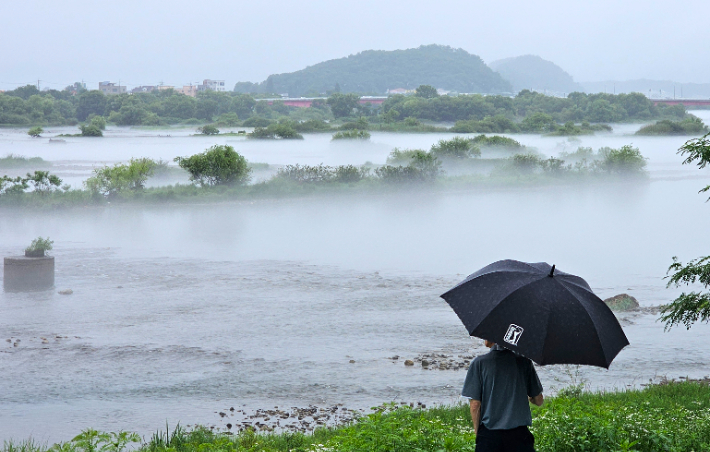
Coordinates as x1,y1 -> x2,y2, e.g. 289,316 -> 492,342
0,85 -> 687,129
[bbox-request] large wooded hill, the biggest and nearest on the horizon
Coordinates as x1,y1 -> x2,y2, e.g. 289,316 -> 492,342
234,45 -> 512,97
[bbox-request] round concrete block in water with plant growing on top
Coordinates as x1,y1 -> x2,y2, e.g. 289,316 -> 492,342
3,256 -> 54,292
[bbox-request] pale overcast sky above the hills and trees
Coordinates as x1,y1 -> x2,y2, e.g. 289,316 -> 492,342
0,0 -> 710,89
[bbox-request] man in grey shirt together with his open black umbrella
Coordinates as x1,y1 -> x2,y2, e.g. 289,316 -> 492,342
442,260 -> 629,452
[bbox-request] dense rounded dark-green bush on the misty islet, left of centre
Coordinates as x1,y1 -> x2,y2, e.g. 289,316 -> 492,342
175,145 -> 251,187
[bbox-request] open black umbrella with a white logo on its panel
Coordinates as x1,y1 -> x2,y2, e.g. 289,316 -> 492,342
441,260 -> 629,369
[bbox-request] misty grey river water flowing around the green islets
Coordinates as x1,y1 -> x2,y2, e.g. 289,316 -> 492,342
0,116 -> 710,441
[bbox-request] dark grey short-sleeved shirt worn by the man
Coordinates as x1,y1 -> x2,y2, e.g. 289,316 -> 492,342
461,346 -> 542,430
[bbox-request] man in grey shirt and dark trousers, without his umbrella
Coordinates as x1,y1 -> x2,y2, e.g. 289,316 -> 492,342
461,341 -> 543,452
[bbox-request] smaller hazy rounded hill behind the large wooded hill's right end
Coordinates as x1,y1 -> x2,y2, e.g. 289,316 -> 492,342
489,55 -> 583,94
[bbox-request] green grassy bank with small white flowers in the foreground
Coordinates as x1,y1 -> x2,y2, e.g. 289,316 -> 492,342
5,382 -> 710,452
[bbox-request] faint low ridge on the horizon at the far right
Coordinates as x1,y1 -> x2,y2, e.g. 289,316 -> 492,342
582,79 -> 710,99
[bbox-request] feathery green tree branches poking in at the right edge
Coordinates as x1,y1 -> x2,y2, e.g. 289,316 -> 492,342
660,133 -> 710,329
